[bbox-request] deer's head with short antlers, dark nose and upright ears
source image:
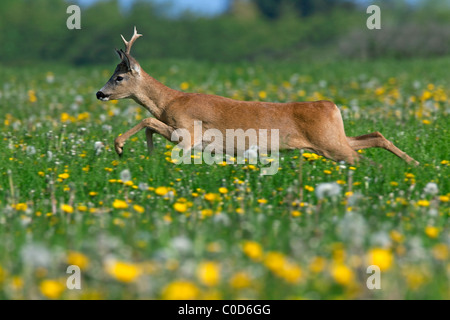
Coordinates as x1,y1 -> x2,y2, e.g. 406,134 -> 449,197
97,27 -> 142,101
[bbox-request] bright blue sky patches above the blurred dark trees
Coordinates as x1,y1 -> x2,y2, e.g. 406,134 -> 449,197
77,0 -> 229,15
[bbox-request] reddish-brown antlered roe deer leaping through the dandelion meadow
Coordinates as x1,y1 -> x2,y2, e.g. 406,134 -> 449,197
97,27 -> 419,165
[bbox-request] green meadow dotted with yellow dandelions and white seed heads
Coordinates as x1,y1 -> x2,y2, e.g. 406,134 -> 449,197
0,58 -> 450,299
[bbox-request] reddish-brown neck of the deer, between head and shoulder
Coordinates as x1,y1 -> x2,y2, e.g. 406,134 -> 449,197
133,71 -> 183,119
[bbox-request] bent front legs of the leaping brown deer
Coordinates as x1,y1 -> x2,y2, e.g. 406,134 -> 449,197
114,118 -> 174,156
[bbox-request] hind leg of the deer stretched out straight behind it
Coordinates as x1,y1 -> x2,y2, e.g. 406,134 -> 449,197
347,132 -> 419,165
